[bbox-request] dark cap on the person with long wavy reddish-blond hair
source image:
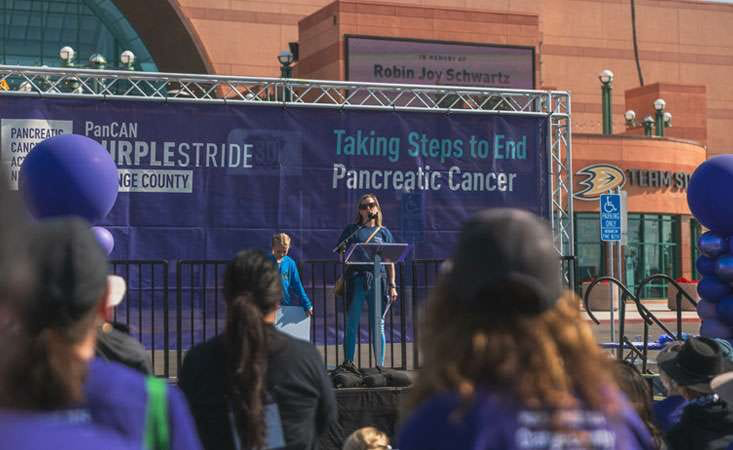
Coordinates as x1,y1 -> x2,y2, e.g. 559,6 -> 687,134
448,208 -> 565,314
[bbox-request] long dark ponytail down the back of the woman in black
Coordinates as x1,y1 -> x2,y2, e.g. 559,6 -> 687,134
227,294 -> 267,448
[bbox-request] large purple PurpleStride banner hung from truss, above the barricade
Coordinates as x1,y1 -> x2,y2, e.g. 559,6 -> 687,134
0,97 -> 549,260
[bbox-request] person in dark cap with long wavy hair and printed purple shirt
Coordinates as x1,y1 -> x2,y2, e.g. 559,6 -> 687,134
397,209 -> 654,450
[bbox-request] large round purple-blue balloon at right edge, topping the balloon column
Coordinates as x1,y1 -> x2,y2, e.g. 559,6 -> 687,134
687,155 -> 733,234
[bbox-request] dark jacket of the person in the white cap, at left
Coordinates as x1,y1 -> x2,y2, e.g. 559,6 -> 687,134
97,323 -> 153,375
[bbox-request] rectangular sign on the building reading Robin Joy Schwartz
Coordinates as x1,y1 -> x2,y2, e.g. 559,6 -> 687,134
346,36 -> 534,89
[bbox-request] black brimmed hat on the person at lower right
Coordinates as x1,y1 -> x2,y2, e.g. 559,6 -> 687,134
657,337 -> 732,392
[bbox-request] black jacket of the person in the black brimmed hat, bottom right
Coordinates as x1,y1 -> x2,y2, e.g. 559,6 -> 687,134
666,400 -> 733,450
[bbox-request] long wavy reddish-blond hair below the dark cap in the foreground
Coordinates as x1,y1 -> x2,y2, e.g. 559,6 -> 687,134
407,284 -> 617,413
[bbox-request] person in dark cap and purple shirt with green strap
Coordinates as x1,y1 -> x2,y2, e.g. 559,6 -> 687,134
0,218 -> 201,450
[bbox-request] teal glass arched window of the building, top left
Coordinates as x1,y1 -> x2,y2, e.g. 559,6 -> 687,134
0,0 -> 158,72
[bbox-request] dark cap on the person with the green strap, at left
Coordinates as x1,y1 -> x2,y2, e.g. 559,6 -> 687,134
29,217 -> 109,330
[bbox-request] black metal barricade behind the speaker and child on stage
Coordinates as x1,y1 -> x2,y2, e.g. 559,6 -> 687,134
112,259 -> 573,377
